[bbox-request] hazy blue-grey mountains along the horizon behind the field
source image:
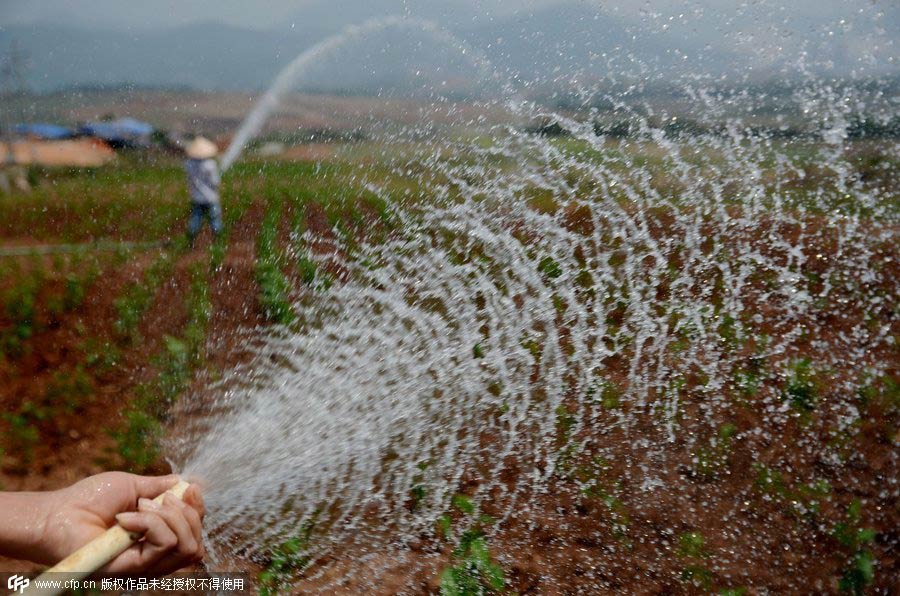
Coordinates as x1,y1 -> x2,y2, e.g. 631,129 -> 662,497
0,0 -> 892,91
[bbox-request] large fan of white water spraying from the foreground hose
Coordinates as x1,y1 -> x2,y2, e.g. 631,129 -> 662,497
168,78 -> 895,581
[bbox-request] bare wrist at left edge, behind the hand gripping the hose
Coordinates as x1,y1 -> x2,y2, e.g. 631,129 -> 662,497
0,492 -> 52,563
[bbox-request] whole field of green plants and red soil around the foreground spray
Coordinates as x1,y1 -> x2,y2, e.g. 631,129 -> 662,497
0,132 -> 900,594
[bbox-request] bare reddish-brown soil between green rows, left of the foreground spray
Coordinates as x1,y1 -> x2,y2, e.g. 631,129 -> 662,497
0,207 -> 262,570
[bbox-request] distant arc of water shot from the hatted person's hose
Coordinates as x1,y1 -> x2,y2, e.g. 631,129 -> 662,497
221,16 -> 493,171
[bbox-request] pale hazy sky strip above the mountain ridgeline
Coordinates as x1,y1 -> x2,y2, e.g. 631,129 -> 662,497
0,0 -> 900,28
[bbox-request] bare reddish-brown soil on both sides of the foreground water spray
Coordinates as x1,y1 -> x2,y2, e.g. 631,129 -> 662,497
0,193 -> 900,594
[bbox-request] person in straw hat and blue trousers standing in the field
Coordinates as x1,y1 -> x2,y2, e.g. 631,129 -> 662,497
184,137 -> 222,247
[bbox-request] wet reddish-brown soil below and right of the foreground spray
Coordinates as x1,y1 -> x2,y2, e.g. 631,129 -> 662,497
284,212 -> 900,594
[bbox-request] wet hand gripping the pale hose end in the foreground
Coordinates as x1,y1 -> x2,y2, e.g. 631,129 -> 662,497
35,472 -> 205,576
